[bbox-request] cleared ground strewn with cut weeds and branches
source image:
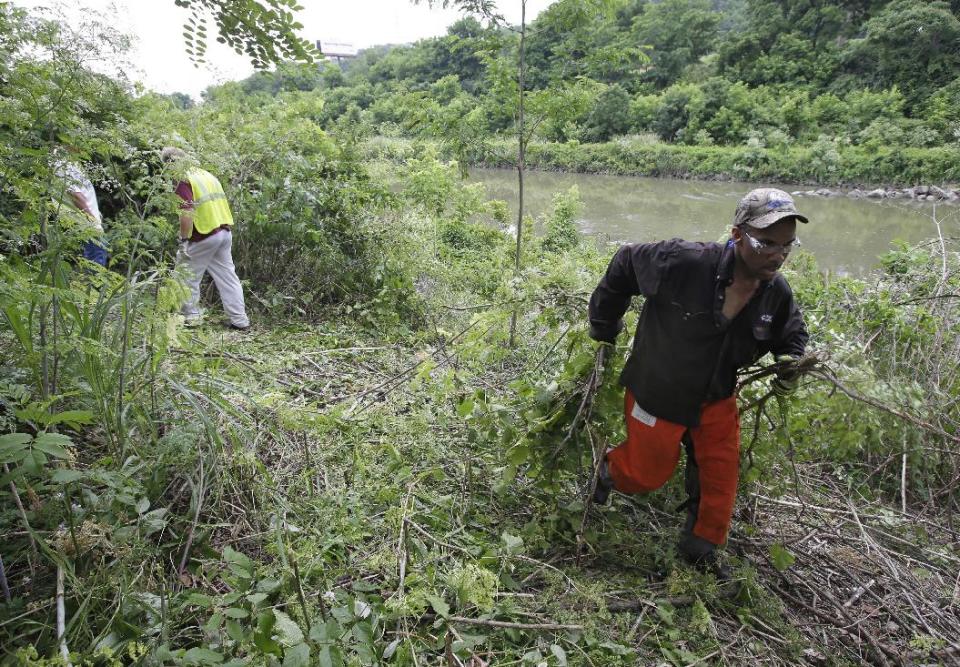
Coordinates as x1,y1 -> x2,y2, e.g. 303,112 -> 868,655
152,294 -> 958,665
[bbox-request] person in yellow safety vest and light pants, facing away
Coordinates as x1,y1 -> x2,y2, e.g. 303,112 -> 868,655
160,146 -> 250,331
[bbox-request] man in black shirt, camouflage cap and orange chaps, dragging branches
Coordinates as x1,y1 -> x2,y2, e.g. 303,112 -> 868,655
590,188 -> 807,575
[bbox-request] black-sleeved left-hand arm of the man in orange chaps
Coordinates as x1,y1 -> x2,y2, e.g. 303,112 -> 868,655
589,242 -> 671,343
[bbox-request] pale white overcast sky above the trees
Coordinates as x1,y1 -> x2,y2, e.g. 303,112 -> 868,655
13,0 -> 554,99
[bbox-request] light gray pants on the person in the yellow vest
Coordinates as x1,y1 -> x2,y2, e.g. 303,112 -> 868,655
177,229 -> 250,327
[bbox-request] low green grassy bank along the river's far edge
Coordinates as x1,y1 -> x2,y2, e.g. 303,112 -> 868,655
365,137 -> 960,194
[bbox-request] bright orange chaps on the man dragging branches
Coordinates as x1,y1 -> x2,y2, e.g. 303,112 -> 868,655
607,391 -> 740,544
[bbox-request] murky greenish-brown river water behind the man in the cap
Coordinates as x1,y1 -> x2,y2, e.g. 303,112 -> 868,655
470,169 -> 960,276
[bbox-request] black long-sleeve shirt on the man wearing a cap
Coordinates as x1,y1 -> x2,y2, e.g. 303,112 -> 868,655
590,239 -> 807,426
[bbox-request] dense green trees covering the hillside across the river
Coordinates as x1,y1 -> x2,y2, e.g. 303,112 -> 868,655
288,0 -> 960,157
